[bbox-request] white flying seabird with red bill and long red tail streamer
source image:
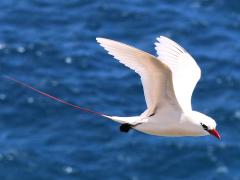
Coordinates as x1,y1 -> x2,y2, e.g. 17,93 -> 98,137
7,36 -> 221,139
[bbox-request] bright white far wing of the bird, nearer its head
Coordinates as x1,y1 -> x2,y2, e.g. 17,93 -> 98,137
155,36 -> 201,111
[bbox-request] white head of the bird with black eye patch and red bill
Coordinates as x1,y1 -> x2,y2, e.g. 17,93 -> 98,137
188,111 -> 221,140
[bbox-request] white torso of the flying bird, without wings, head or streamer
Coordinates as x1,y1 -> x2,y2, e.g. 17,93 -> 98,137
109,107 -> 208,137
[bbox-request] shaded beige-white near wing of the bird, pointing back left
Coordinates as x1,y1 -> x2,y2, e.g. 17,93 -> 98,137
96,38 -> 177,113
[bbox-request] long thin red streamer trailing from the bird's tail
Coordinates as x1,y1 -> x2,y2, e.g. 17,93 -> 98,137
4,76 -> 107,117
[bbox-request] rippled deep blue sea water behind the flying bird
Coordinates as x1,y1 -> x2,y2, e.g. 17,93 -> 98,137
0,0 -> 240,180
